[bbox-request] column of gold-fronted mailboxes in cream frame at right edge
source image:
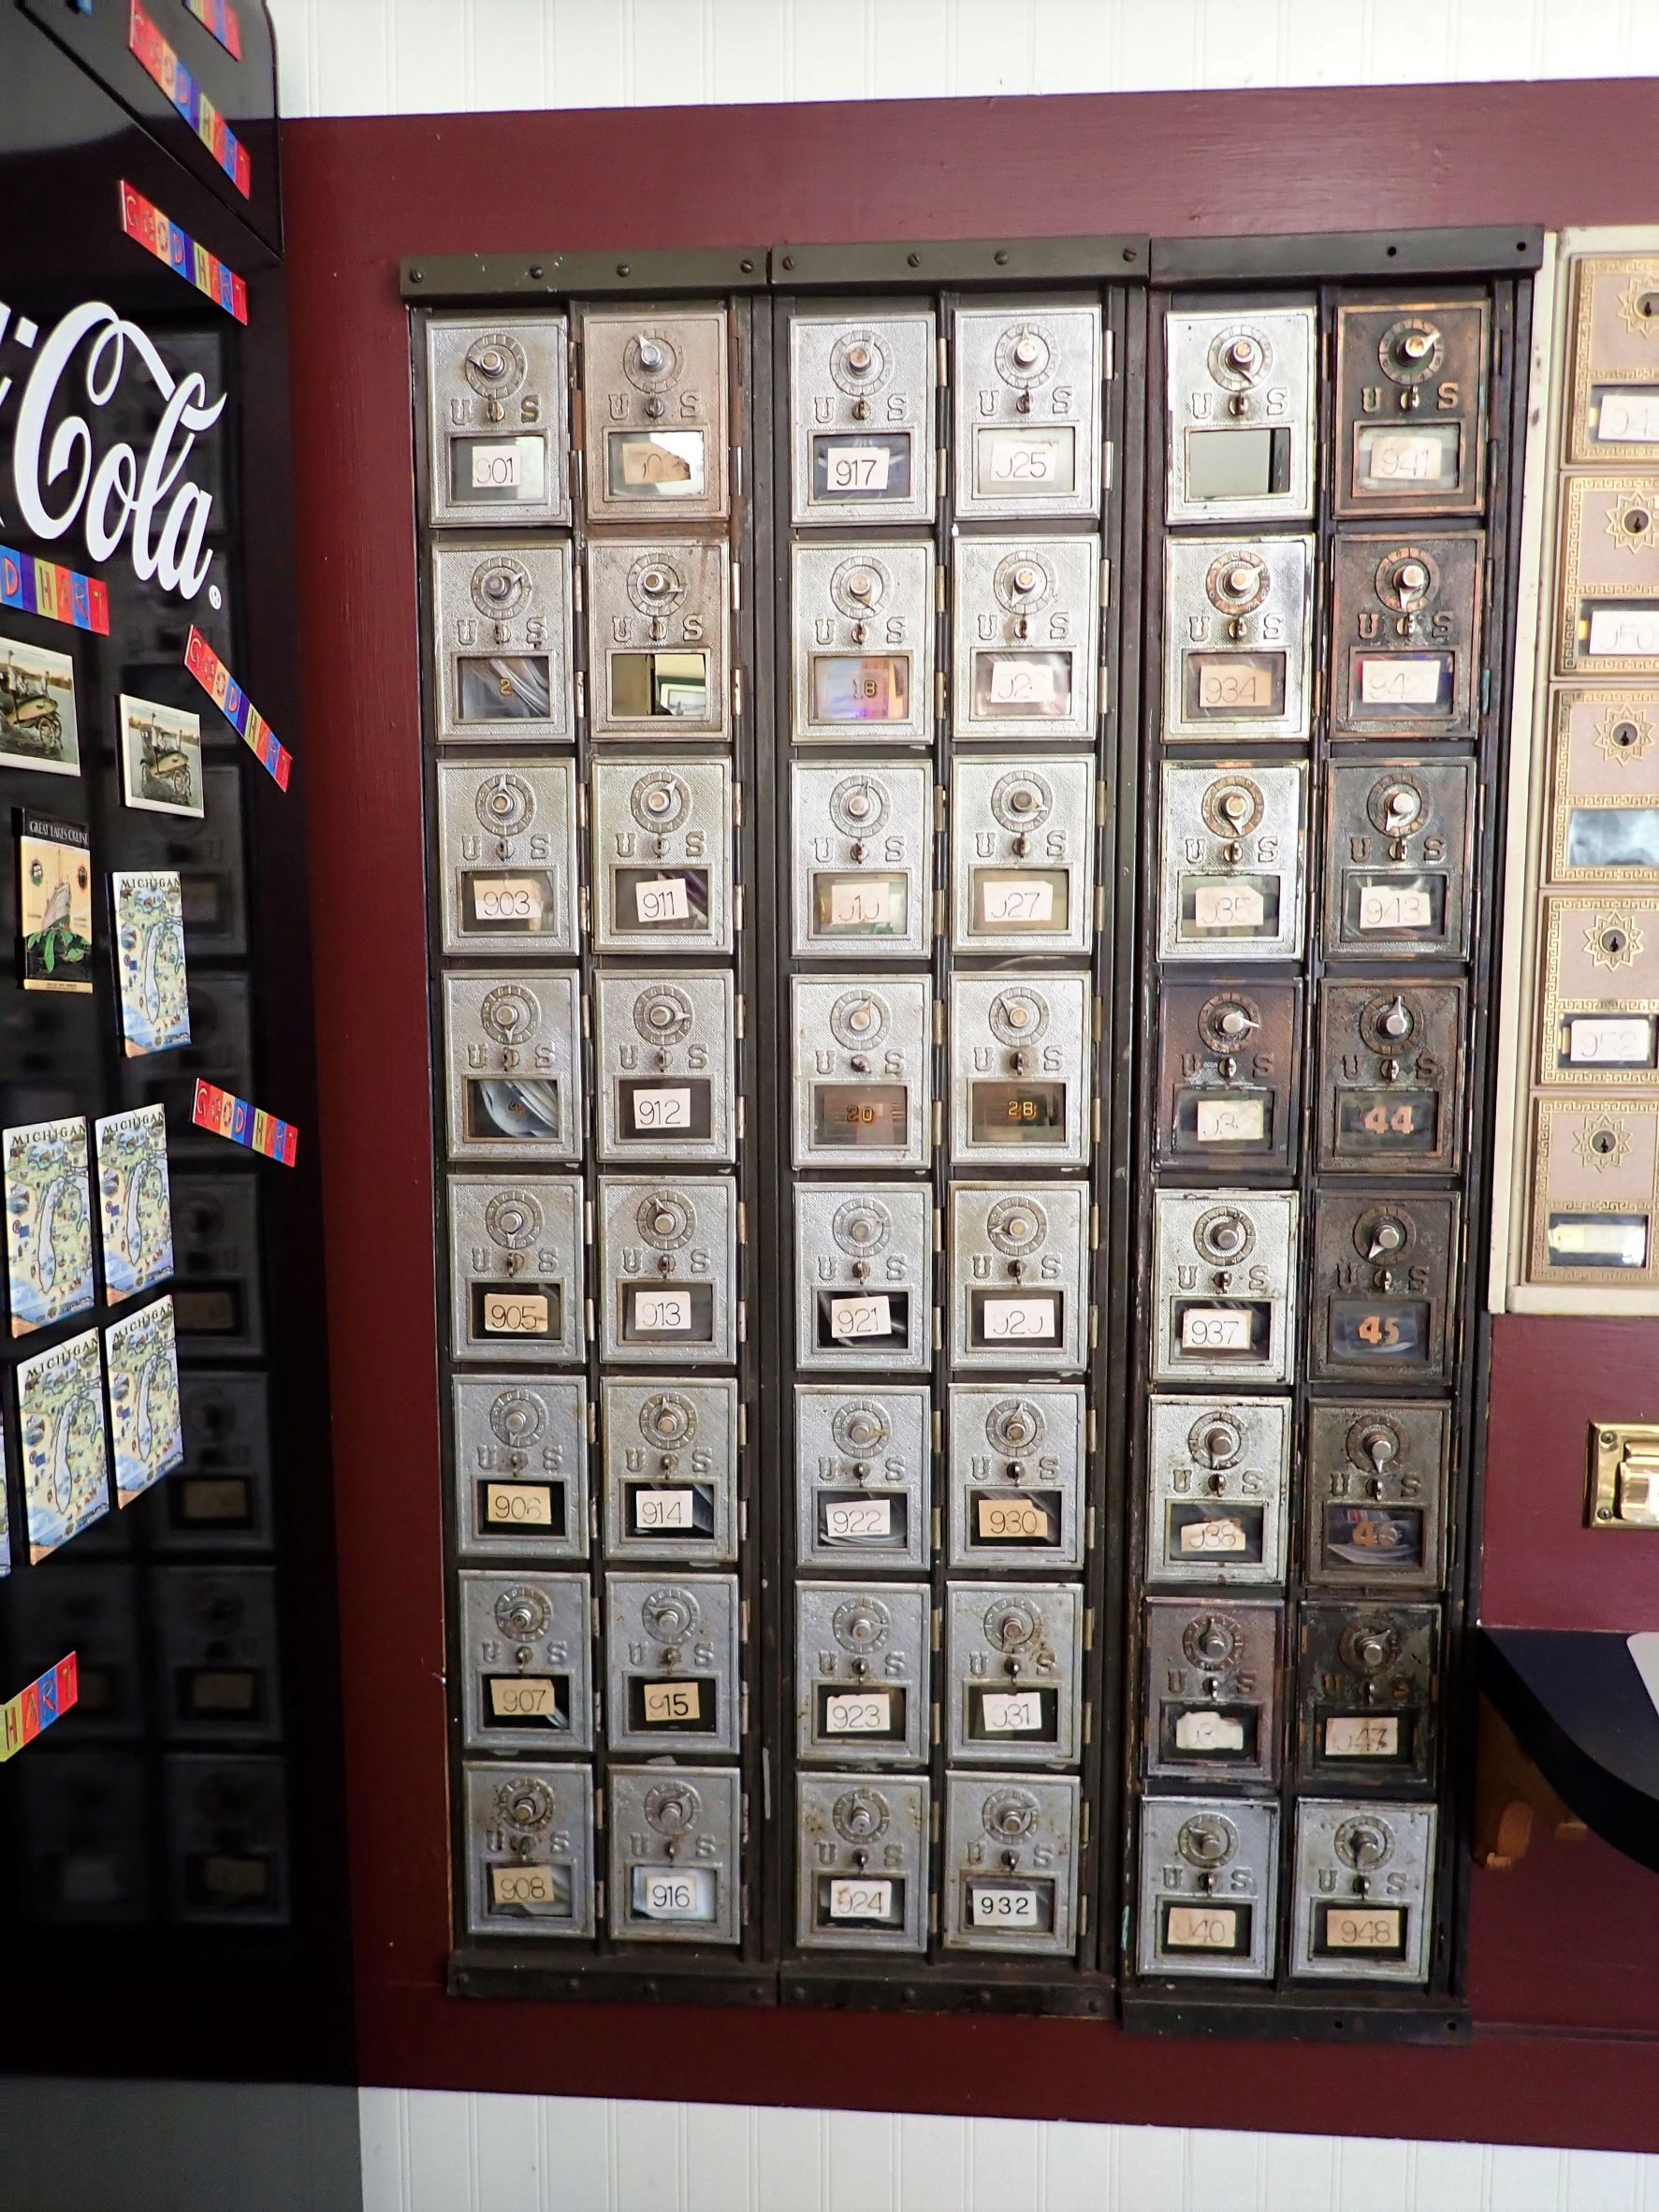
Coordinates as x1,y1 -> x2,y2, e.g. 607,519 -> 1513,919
1491,227 -> 1659,1314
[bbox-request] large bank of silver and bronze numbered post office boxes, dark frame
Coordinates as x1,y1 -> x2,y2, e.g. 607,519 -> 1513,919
405,232 -> 1537,2042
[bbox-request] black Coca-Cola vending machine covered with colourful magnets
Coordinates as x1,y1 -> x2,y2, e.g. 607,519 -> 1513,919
0,0 -> 352,2079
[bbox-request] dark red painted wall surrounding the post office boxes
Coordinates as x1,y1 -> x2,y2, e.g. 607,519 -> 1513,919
284,81 -> 1659,2150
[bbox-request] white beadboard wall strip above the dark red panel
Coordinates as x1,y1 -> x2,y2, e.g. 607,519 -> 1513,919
269,0 -> 1659,115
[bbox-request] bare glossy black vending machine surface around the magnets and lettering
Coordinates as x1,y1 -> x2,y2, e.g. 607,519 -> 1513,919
0,5 -> 352,2079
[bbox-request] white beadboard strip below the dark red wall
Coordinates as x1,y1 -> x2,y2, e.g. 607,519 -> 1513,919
360,2088 -> 1659,2212
